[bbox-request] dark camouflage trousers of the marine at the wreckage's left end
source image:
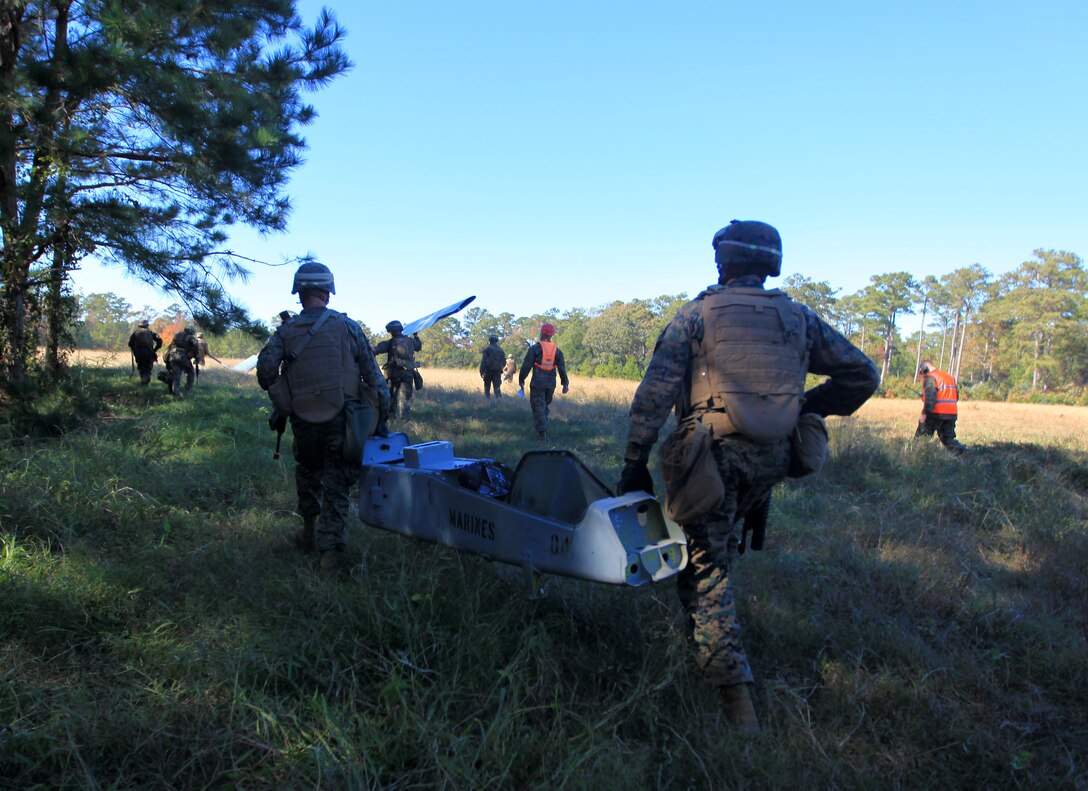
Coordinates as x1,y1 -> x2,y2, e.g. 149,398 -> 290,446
290,412 -> 359,552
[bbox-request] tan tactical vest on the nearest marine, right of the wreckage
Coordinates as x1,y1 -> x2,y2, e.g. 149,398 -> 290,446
691,288 -> 808,442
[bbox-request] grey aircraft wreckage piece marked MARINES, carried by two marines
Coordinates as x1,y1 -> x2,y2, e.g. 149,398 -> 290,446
359,433 -> 688,588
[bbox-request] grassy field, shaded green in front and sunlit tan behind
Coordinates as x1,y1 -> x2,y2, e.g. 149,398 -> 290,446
0,357 -> 1088,791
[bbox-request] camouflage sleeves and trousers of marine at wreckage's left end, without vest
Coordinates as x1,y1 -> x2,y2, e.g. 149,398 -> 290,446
257,307 -> 390,552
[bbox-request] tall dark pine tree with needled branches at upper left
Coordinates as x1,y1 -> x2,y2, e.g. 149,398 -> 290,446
0,0 -> 349,382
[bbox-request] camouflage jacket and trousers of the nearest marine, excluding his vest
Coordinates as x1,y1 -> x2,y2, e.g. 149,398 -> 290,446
626,275 -> 879,687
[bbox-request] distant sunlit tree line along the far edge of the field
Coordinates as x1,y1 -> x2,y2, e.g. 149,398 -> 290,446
73,244 -> 1088,403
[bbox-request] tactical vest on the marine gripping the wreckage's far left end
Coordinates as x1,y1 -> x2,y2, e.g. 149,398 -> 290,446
276,309 -> 362,423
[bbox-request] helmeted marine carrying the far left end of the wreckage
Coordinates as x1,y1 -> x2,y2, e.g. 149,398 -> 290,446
257,261 -> 390,573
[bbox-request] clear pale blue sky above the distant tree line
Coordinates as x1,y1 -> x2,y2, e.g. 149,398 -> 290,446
75,0 -> 1088,330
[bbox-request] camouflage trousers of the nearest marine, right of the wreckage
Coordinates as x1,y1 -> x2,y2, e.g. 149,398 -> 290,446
677,438 -> 790,687
